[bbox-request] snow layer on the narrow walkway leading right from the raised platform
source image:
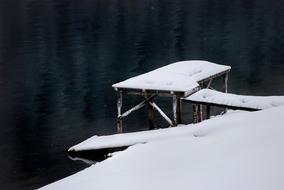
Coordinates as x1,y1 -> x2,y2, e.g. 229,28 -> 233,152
184,89 -> 284,109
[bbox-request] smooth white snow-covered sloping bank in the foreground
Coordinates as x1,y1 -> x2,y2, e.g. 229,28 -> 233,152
43,106 -> 284,190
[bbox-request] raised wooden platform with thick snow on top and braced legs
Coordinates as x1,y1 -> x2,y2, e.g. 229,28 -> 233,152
113,60 -> 231,132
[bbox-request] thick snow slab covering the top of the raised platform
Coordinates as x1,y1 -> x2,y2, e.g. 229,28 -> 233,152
112,60 -> 231,92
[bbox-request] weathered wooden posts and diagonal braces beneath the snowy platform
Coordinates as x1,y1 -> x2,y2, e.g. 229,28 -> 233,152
115,69 -> 230,133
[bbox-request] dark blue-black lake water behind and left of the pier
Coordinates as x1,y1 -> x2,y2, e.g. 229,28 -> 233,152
0,0 -> 284,189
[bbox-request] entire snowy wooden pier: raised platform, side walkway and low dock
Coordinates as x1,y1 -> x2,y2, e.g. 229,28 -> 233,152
68,61 -> 284,162
